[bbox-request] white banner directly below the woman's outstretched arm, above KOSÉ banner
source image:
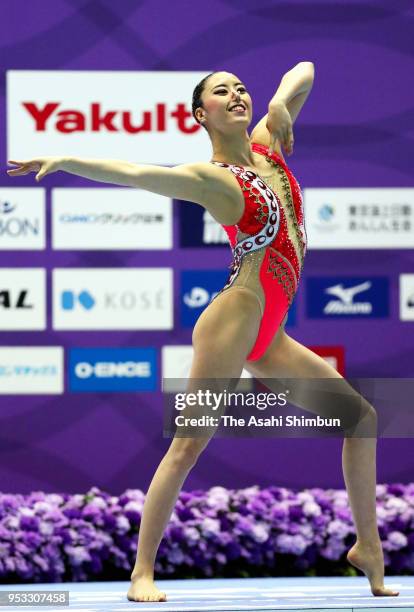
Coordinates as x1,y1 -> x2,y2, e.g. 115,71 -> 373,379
52,188 -> 172,251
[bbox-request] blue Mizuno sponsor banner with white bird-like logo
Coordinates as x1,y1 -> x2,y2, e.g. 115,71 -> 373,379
306,276 -> 389,319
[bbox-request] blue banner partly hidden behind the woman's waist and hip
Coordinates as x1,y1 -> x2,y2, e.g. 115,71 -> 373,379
181,269 -> 296,327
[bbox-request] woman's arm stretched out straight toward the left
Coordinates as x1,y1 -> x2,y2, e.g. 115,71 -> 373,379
7,157 -> 239,222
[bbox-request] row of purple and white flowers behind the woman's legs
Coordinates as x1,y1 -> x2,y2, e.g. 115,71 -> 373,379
0,483 -> 414,584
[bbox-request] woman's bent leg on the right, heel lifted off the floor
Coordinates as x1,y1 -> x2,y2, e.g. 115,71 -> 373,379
245,329 -> 398,595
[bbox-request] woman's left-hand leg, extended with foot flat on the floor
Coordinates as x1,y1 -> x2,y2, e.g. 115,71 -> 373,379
127,291 -> 260,601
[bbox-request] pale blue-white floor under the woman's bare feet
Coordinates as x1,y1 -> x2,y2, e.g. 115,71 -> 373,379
0,576 -> 414,612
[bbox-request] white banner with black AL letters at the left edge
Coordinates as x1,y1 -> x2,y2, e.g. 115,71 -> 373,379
0,268 -> 46,331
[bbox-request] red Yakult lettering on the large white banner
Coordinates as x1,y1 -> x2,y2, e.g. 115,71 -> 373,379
22,102 -> 200,134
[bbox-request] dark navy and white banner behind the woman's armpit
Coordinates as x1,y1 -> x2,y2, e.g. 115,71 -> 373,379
179,201 -> 229,248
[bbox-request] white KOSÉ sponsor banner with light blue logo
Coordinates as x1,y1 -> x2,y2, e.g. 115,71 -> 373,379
53,268 -> 173,330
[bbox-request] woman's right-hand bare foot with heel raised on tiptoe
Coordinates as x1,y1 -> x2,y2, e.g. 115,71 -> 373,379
346,542 -> 399,597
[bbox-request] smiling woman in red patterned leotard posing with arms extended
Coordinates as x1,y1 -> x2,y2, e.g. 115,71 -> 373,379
8,62 -> 398,601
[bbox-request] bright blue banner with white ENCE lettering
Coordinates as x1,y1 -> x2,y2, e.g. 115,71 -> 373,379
69,348 -> 157,392
